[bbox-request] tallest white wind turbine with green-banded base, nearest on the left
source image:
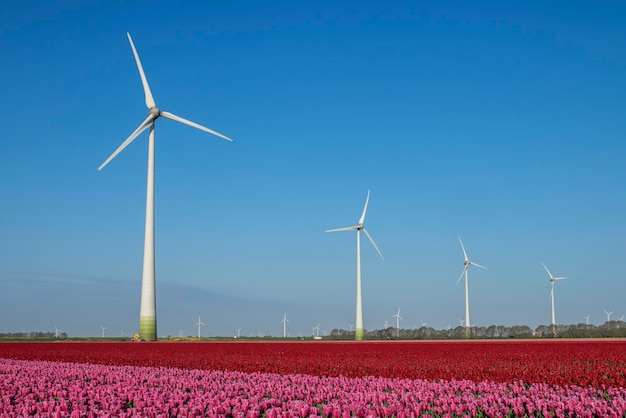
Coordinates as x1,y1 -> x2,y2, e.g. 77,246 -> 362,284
98,33 -> 232,341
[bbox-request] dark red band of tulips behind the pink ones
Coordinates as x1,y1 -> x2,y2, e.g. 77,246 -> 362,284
0,340 -> 626,388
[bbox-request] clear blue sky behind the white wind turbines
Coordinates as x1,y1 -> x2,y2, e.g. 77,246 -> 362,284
0,1 -> 626,336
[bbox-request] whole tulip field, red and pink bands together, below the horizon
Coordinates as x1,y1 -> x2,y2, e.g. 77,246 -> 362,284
0,340 -> 626,417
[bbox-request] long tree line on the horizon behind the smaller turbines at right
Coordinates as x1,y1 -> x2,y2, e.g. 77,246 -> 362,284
330,321 -> 626,340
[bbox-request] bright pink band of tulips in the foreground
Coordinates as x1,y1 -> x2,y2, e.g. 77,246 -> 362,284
0,359 -> 626,417
